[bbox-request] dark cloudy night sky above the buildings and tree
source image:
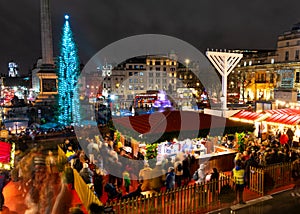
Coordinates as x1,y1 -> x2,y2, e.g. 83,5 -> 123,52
0,0 -> 300,74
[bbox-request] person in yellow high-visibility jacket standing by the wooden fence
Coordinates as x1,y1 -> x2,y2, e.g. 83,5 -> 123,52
232,160 -> 246,204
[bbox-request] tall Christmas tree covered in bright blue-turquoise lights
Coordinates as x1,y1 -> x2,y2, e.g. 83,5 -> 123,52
57,15 -> 80,125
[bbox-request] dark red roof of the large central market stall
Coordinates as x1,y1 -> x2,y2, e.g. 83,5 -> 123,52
113,111 -> 251,134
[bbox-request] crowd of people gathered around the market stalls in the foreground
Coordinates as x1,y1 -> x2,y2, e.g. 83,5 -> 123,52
1,125 -> 300,212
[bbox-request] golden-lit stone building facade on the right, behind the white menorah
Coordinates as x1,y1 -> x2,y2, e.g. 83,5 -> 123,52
228,23 -> 300,102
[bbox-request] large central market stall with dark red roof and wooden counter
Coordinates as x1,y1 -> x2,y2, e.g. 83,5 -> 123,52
113,111 -> 253,176
